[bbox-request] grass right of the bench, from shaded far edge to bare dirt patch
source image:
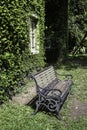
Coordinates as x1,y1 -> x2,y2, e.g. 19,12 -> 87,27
56,55 -> 87,102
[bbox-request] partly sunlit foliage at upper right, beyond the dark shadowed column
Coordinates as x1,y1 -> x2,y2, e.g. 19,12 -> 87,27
69,0 -> 87,54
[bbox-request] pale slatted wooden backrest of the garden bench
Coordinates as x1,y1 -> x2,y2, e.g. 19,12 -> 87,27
34,66 -> 57,88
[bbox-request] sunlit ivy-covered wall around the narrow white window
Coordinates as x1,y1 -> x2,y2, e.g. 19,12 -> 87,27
0,0 -> 45,103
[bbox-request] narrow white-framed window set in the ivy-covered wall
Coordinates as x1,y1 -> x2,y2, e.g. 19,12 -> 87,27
30,15 -> 39,54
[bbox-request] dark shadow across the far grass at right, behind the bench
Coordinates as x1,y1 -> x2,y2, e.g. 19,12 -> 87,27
55,55 -> 87,70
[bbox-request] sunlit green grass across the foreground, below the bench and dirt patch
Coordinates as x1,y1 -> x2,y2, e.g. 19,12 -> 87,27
0,103 -> 87,130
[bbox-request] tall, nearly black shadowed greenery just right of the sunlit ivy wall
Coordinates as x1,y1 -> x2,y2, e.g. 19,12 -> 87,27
45,0 -> 68,63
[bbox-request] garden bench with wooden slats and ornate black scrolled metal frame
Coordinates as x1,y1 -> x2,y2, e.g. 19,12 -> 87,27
31,66 -> 73,119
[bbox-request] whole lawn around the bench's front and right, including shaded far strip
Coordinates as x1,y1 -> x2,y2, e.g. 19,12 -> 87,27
0,56 -> 87,130
